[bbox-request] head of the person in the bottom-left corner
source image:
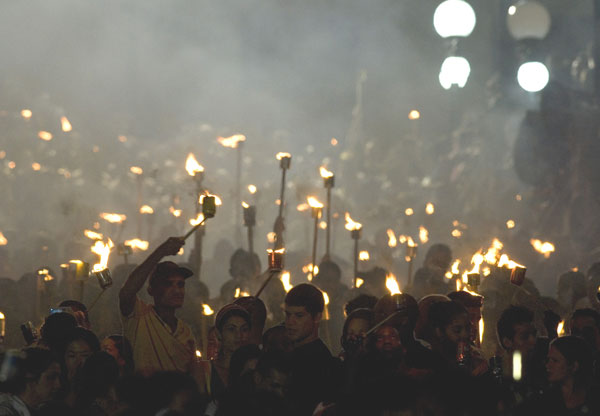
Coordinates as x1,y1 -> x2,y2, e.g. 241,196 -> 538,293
5,348 -> 60,408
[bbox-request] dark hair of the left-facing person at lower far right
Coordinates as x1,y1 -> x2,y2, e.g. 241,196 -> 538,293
550,335 -> 594,387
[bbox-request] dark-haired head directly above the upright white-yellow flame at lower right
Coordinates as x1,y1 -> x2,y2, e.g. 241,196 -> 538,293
496,306 -> 537,357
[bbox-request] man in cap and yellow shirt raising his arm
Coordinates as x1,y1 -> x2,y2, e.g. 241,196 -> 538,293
119,237 -> 196,374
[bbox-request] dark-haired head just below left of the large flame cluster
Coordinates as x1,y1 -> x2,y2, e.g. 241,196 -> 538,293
429,301 -> 471,351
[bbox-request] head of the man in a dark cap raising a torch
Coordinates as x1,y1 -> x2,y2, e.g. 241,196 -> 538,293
148,261 -> 193,309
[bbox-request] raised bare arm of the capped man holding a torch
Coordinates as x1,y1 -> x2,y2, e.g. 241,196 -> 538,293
119,237 -> 185,315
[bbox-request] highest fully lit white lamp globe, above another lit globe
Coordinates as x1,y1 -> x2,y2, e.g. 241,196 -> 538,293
433,0 -> 476,38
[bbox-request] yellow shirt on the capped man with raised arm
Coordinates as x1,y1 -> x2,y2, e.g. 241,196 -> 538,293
121,297 -> 196,374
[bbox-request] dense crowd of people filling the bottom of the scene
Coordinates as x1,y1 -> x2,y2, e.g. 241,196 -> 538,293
0,237 -> 600,416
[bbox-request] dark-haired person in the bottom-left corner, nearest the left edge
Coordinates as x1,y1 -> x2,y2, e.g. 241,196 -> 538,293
0,347 -> 60,416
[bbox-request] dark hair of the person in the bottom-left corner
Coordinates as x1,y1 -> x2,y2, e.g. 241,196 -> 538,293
0,347 -> 58,394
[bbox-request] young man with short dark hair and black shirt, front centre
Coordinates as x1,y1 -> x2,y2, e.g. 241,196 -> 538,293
284,283 -> 335,415
